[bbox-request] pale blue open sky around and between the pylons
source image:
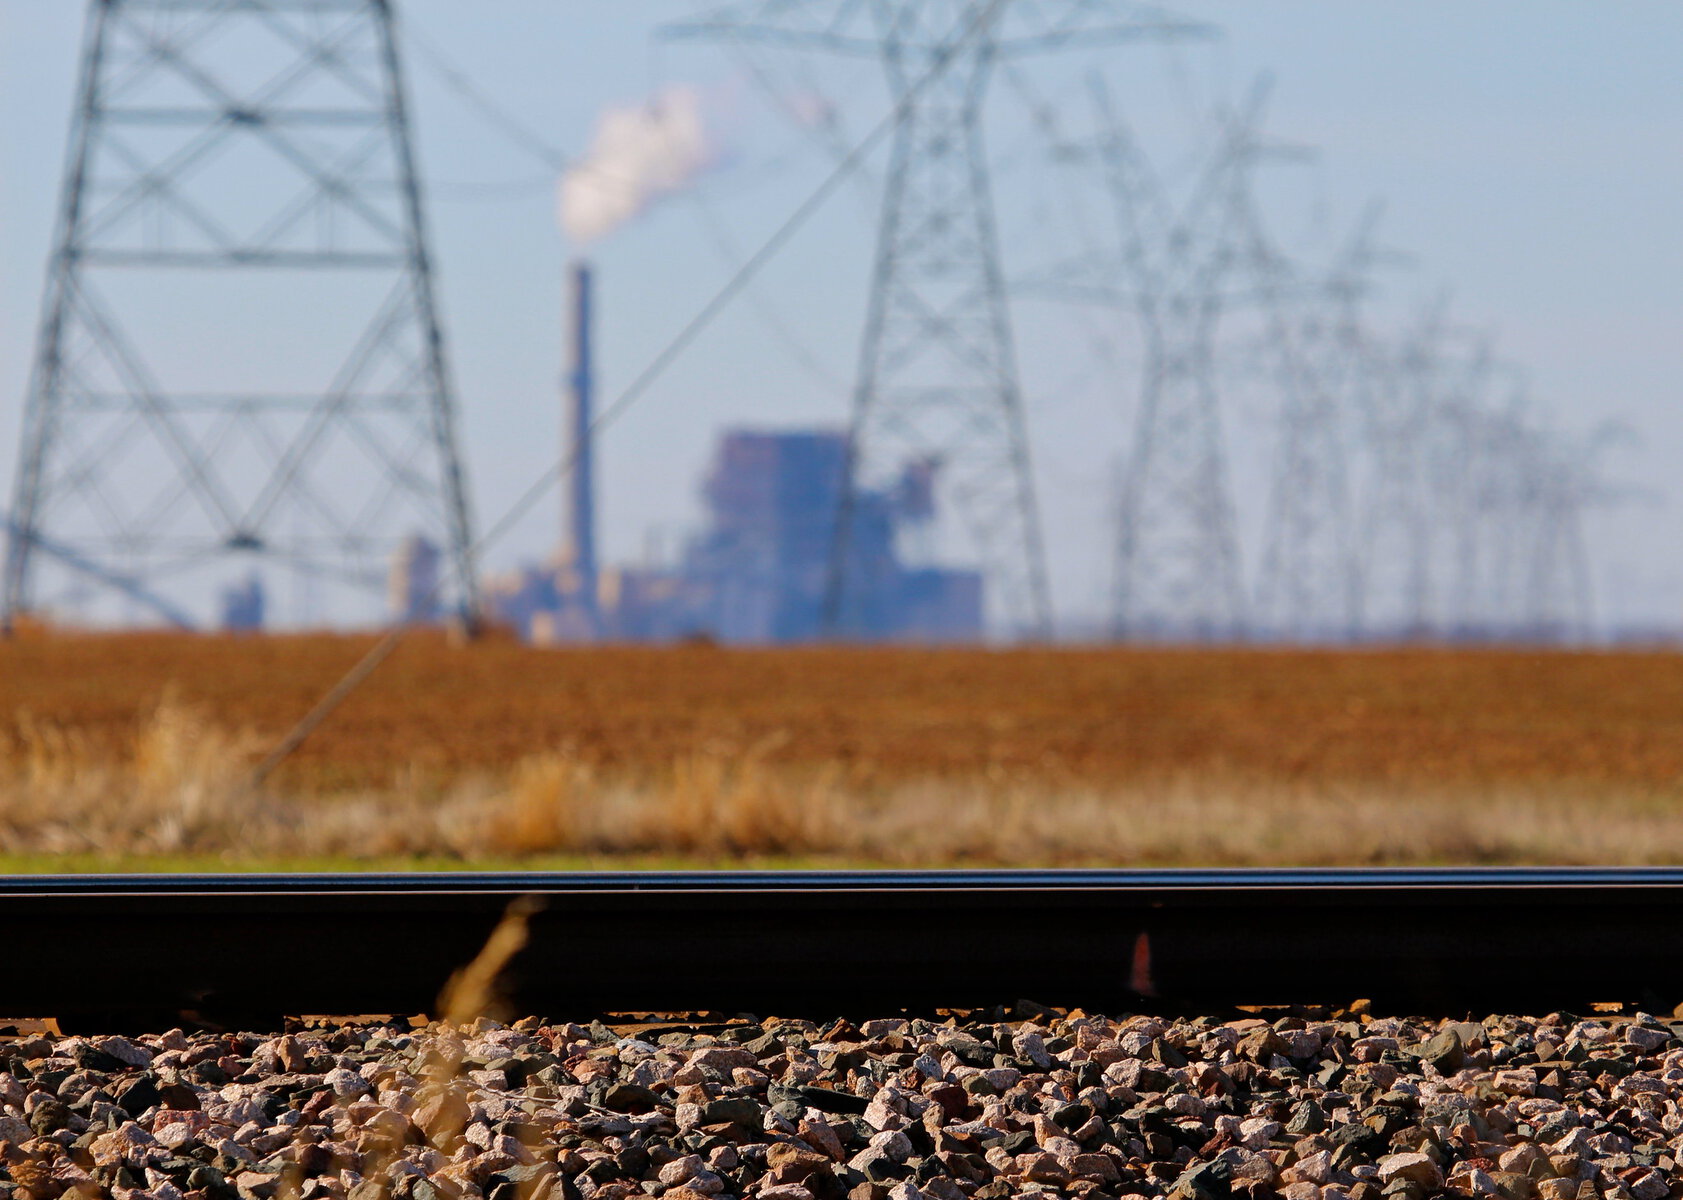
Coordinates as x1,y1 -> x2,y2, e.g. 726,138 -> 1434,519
0,0 -> 1683,626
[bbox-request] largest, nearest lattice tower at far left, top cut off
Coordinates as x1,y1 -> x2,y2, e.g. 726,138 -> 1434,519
3,0 -> 476,632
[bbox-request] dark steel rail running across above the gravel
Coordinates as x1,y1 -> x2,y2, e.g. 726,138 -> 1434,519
0,868 -> 1683,1027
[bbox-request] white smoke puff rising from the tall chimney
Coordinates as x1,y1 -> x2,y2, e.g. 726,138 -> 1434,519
560,86 -> 715,242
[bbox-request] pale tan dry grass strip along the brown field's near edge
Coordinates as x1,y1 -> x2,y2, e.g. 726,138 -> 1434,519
0,704 -> 1683,865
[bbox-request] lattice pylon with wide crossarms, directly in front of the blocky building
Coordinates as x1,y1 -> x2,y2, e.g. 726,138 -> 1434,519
673,0 -> 1195,636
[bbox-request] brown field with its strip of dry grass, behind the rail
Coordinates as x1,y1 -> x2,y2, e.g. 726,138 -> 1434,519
0,633 -> 1683,863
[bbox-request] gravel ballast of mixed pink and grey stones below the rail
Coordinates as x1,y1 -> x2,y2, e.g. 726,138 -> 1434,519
0,1012 -> 1683,1200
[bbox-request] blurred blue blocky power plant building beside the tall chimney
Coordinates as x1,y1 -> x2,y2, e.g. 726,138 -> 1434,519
485,429 -> 983,643
